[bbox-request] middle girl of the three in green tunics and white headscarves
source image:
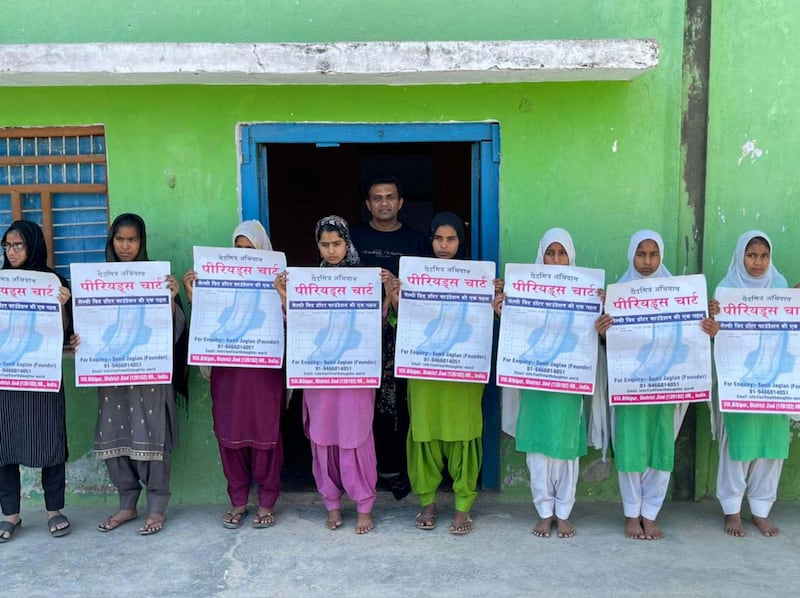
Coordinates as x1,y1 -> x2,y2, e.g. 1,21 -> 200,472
595,230 -> 719,540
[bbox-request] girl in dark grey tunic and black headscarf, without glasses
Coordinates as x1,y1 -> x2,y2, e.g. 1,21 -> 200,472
71,214 -> 186,536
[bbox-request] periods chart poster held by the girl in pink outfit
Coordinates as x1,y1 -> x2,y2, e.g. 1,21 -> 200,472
286,268 -> 381,388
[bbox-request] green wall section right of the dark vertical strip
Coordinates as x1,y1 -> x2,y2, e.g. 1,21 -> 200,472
697,0 -> 800,498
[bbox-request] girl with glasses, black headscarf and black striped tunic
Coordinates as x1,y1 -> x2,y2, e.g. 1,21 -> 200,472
0,220 -> 71,543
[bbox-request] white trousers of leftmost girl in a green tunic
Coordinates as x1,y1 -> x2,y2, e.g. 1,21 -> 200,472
525,453 -> 579,519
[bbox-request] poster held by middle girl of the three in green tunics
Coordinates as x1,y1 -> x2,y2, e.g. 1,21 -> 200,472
606,274 -> 711,405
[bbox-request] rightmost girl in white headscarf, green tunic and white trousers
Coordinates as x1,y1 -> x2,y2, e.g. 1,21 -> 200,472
712,230 -> 791,537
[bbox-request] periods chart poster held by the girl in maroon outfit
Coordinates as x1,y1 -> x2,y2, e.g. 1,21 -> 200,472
189,247 -> 286,368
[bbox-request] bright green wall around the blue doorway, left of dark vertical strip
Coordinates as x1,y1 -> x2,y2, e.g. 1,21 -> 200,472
0,0 -> 691,503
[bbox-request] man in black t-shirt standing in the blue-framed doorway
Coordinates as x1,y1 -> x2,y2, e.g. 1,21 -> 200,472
351,177 -> 430,500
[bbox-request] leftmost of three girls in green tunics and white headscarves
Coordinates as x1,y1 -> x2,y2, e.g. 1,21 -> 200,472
494,228 -> 586,538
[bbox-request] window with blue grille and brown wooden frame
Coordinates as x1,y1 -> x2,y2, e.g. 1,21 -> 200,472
0,126 -> 108,278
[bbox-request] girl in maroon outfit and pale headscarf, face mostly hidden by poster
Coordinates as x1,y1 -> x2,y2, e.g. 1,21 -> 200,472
183,220 -> 284,529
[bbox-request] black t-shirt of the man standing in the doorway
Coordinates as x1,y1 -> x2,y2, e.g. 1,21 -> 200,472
351,223 -> 429,276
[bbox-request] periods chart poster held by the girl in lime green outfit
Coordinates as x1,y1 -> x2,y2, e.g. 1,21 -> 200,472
394,257 -> 495,383
